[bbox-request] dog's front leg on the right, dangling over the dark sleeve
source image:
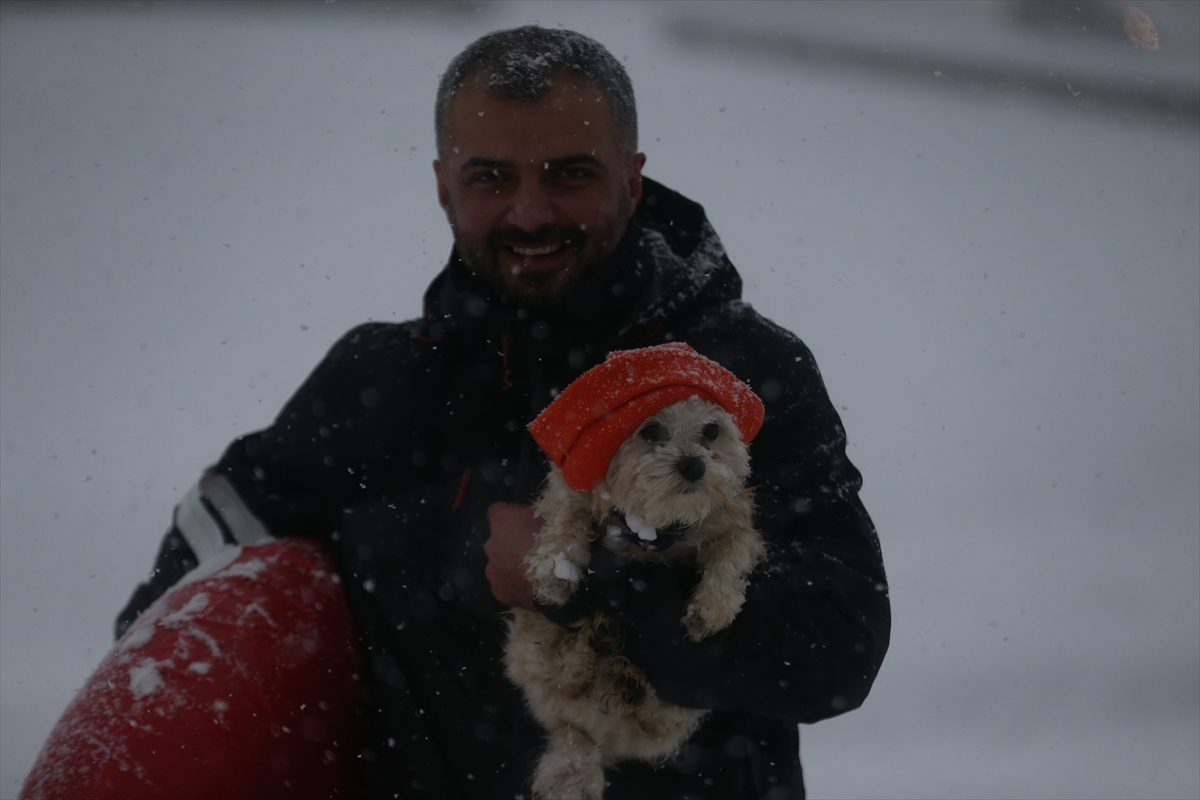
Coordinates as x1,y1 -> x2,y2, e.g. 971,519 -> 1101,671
683,503 -> 767,642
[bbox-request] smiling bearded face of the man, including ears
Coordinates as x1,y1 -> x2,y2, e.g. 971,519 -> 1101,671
433,77 -> 646,305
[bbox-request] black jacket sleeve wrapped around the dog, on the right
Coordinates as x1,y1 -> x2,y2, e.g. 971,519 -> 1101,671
544,315 -> 890,722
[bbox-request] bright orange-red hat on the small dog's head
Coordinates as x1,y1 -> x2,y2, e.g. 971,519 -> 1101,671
529,342 -> 763,492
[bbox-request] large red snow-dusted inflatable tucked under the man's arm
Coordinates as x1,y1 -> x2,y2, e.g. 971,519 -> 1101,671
20,539 -> 361,800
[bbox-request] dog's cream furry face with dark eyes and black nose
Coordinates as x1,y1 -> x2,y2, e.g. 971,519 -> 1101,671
593,397 -> 750,528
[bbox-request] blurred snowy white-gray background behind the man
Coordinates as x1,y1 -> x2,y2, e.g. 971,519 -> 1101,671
0,0 -> 1200,798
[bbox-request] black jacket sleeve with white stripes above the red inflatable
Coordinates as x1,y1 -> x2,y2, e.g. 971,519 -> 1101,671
116,323 -> 437,637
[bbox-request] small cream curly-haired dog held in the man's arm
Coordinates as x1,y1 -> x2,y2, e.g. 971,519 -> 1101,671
505,397 -> 766,800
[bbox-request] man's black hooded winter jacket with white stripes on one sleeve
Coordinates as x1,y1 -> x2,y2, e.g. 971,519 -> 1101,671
118,180 -> 890,798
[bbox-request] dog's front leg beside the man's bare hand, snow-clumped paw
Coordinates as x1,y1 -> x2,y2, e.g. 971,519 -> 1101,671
526,467 -> 595,606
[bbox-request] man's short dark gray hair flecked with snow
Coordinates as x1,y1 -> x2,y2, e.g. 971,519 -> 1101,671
433,25 -> 637,160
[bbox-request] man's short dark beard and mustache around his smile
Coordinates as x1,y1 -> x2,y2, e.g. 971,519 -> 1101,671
449,198 -> 630,307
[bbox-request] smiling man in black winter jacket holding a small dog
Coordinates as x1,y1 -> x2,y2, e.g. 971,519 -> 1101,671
118,26 -> 890,798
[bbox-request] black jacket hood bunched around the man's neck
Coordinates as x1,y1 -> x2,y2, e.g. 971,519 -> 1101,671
420,178 -> 742,338
